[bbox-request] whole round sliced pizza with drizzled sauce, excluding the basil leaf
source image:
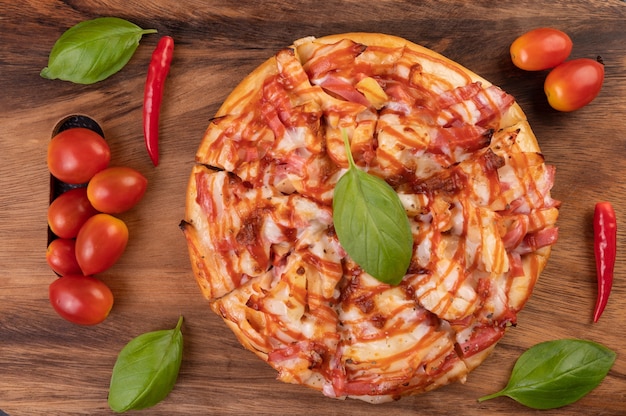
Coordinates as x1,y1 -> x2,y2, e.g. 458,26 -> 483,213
181,33 -> 559,403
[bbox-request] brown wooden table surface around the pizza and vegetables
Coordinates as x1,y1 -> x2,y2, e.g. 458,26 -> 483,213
0,0 -> 626,416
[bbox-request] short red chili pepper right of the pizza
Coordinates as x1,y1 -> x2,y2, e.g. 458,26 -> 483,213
593,202 -> 617,322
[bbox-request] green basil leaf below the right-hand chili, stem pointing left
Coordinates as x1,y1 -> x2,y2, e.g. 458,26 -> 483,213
478,339 -> 616,409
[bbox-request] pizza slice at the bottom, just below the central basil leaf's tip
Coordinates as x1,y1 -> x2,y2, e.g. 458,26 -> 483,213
332,275 -> 464,396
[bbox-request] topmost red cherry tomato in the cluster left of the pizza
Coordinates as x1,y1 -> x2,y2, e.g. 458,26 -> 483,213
48,127 -> 111,184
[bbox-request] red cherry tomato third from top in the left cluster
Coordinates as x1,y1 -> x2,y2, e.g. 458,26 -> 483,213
48,188 -> 98,238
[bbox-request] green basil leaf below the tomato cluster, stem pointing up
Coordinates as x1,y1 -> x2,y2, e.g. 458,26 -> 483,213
108,316 -> 183,412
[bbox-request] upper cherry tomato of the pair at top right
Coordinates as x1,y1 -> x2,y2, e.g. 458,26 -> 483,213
510,27 -> 572,71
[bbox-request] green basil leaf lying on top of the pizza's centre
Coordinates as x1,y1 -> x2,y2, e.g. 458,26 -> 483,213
333,131 -> 413,284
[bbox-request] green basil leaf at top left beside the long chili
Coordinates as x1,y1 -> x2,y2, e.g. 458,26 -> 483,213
40,17 -> 156,84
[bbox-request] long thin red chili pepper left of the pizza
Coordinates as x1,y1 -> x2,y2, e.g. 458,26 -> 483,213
143,36 -> 174,166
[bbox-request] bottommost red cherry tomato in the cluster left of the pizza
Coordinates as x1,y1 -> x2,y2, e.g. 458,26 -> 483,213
49,275 -> 113,325
